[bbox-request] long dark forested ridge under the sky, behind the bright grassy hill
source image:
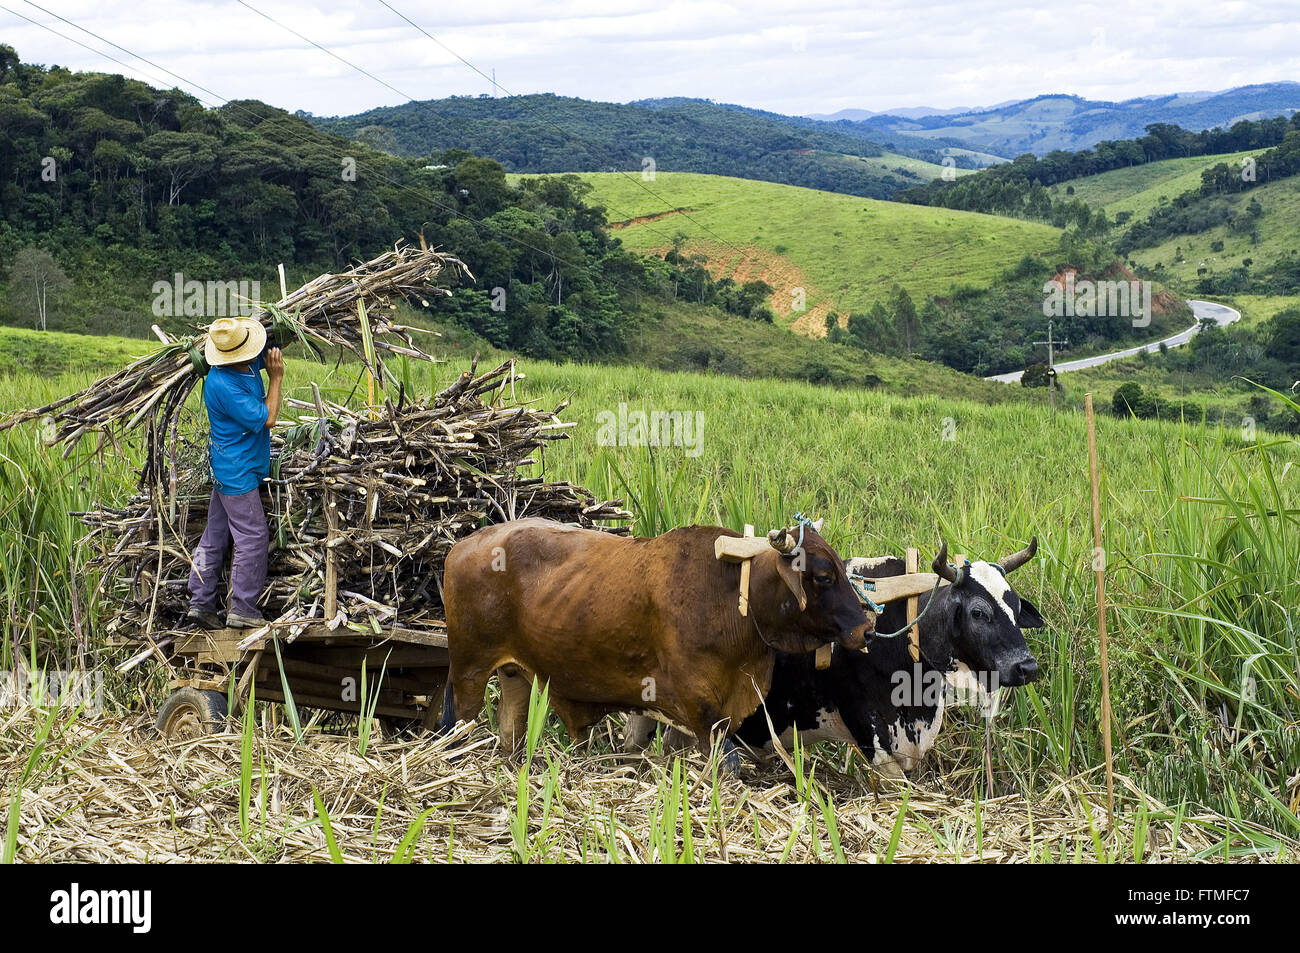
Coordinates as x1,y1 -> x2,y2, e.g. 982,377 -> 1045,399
311,94 -> 975,198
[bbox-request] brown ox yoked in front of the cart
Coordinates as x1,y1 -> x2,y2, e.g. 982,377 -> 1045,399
441,519 -> 871,764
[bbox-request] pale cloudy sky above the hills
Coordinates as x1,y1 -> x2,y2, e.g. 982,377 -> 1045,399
0,0 -> 1300,116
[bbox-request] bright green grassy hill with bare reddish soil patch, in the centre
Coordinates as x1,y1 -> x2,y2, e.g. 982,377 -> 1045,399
564,173 -> 1060,334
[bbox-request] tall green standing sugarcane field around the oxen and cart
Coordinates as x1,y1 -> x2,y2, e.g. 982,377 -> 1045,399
0,328 -> 1300,859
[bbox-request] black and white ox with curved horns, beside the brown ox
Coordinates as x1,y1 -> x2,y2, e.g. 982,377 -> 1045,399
736,537 -> 1043,774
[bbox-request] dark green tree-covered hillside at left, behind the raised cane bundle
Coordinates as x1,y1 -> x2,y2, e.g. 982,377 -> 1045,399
0,46 -> 771,359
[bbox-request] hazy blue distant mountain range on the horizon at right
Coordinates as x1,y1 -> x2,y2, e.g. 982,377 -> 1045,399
823,82 -> 1300,157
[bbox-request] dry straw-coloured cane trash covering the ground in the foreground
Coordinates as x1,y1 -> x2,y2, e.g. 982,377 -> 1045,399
0,709 -> 1284,863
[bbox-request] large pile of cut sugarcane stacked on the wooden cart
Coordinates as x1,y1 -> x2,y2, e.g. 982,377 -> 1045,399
82,361 -> 631,634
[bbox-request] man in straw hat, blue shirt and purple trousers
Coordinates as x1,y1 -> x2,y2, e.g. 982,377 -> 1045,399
187,317 -> 285,629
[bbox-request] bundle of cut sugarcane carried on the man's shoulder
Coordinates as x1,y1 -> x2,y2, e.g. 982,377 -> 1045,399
0,244 -> 473,484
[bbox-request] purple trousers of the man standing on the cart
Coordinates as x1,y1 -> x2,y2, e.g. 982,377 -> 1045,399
190,490 -> 270,618
